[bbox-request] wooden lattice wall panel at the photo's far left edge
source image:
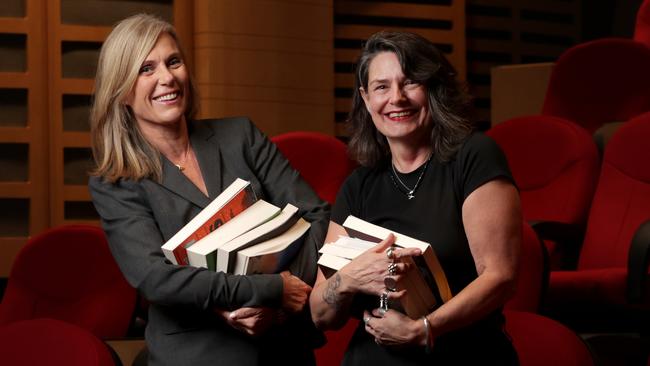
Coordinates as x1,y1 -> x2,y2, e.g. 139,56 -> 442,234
0,0 -> 49,277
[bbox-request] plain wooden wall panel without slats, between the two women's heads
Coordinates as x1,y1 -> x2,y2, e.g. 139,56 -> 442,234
194,0 -> 334,136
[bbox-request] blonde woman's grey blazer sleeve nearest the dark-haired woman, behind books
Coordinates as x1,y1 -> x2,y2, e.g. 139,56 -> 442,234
238,121 -> 330,285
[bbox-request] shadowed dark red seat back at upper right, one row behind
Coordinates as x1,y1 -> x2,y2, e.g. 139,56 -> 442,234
542,38 -> 650,133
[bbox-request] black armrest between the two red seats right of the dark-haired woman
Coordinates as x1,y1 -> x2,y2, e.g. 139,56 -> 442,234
529,221 -> 585,270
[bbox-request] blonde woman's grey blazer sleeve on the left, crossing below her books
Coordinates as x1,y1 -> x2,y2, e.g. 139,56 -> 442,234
89,177 -> 282,310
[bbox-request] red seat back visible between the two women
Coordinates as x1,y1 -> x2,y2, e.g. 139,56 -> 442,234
271,131 -> 355,203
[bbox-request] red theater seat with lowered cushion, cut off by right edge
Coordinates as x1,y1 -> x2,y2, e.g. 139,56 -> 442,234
546,113 -> 650,331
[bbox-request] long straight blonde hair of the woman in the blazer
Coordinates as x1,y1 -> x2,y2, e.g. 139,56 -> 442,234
90,14 -> 198,182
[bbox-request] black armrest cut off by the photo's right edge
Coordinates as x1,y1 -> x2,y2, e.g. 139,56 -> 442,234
627,220 -> 650,303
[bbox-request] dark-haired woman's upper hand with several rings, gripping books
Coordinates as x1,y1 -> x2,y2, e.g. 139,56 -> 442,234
339,234 -> 421,299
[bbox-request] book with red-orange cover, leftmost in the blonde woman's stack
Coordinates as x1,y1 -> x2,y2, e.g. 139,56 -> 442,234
162,178 -> 257,265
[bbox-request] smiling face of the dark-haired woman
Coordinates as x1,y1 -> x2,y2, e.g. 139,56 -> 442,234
360,52 -> 430,143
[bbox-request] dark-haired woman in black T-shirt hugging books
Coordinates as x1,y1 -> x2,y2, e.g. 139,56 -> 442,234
310,32 -> 522,366
